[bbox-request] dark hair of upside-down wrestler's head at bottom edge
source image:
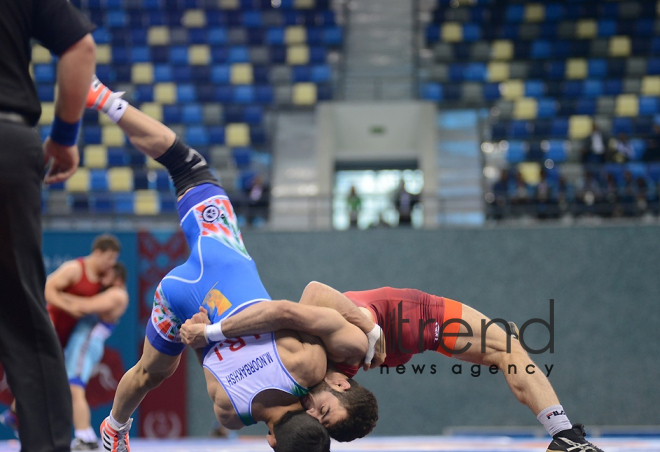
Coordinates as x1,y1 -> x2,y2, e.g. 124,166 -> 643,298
273,410 -> 330,452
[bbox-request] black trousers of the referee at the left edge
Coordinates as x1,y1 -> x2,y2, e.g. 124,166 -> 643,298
0,122 -> 72,452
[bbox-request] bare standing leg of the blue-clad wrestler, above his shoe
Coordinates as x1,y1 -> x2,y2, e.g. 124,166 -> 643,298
111,339 -> 181,424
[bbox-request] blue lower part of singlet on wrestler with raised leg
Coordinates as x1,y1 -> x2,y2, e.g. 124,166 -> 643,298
147,184 -> 271,356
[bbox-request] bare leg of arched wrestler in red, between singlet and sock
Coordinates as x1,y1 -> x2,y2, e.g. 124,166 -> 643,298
445,305 -> 559,415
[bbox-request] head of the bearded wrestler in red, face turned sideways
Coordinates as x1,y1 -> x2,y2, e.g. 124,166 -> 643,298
300,371 -> 378,442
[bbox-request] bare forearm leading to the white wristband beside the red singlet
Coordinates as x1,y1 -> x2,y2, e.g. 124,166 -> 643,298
300,281 -> 376,334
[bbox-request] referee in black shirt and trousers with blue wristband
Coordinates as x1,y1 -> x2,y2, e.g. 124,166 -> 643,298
0,0 -> 96,452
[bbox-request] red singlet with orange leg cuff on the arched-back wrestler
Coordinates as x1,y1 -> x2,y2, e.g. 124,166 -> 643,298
340,287 -> 463,373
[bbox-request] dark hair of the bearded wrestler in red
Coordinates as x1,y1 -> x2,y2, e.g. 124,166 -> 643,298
328,378 -> 378,442
